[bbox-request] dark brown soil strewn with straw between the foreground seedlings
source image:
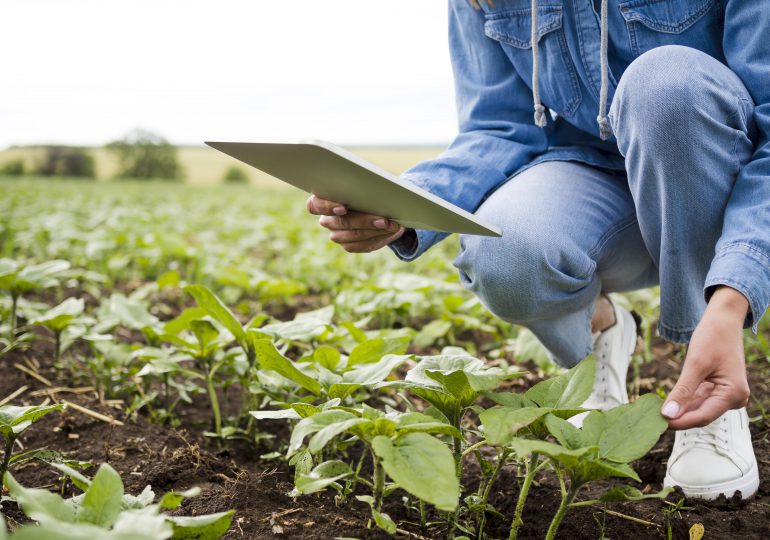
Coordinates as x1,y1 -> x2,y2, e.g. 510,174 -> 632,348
0,316 -> 770,540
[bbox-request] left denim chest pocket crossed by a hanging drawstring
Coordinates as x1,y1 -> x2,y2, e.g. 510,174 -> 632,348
484,6 -> 582,117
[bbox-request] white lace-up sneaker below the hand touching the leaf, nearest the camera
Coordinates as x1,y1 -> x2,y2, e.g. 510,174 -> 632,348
663,408 -> 759,499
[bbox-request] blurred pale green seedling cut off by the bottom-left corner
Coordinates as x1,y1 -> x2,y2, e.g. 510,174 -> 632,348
5,464 -> 234,540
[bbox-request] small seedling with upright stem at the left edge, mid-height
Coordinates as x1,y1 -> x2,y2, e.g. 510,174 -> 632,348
0,259 -> 70,341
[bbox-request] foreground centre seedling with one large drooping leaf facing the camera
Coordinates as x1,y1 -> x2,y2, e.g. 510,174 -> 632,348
252,399 -> 461,532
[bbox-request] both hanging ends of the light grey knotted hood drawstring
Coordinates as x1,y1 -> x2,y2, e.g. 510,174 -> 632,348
530,0 -> 612,141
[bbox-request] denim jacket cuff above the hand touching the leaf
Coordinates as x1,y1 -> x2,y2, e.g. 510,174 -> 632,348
703,242 -> 770,333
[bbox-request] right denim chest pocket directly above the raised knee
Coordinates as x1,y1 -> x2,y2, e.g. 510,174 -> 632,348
618,0 -> 723,56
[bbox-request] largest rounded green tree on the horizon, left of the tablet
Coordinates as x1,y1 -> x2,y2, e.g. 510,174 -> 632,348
106,129 -> 182,180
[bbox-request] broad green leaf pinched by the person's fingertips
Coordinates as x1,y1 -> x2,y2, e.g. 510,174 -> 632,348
599,394 -> 668,463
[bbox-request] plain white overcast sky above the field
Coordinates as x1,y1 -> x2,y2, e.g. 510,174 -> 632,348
0,0 -> 456,148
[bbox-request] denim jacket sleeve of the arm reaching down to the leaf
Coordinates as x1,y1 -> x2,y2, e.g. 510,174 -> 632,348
705,0 -> 770,332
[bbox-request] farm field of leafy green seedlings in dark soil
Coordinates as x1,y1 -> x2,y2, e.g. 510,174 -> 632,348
0,174 -> 770,540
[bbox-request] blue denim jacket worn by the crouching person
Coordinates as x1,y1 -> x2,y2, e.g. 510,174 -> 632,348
391,0 -> 770,321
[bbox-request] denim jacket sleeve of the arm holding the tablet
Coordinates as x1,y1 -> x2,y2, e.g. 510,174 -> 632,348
390,0 -> 548,260
